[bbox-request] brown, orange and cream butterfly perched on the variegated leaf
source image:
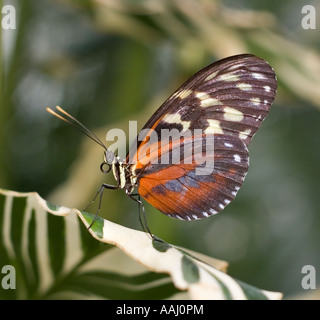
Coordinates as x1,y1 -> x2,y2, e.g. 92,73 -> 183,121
47,54 -> 277,233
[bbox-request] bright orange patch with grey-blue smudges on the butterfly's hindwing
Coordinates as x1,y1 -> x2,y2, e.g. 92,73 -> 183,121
138,165 -> 238,219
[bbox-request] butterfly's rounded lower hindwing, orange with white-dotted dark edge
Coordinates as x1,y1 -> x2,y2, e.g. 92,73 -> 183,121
138,134 -> 248,220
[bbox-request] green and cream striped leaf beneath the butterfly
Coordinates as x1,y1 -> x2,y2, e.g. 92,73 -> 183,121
0,189 -> 282,299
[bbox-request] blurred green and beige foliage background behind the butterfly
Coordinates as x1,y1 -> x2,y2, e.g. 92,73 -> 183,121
0,0 -> 320,298
